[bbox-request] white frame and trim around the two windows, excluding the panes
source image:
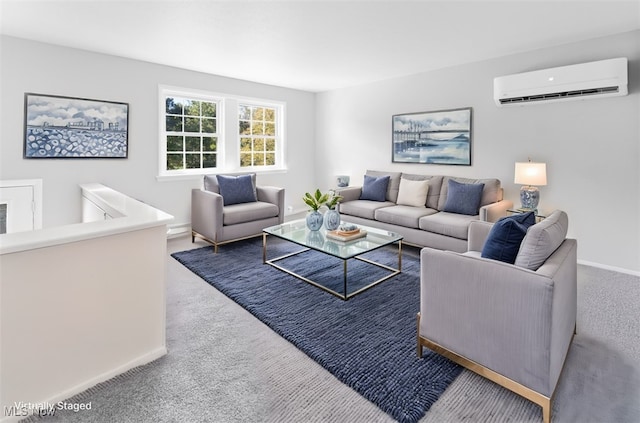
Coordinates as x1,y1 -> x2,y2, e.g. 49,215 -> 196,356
157,85 -> 287,180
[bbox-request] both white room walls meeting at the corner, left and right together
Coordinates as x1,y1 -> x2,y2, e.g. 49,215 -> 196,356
0,31 -> 640,272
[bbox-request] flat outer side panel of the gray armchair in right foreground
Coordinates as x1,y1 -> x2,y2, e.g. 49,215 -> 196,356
419,248 -> 554,395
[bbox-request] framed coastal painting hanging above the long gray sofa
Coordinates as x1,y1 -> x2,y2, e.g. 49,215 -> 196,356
392,107 -> 471,166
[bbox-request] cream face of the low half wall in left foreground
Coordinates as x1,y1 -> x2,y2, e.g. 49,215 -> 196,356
0,225 -> 167,421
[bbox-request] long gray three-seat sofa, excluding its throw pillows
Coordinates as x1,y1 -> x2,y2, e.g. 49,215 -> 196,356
337,170 -> 513,252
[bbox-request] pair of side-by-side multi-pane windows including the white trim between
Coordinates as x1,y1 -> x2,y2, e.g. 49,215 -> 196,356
159,86 -> 285,176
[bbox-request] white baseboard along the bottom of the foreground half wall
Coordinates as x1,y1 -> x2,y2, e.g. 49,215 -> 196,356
0,347 -> 167,423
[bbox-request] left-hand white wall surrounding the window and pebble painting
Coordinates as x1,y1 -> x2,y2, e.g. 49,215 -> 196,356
0,36 -> 315,227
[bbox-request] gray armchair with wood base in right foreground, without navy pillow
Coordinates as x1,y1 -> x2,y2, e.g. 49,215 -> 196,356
418,211 -> 577,423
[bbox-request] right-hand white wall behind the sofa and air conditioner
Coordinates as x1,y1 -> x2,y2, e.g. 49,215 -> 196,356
316,31 -> 640,272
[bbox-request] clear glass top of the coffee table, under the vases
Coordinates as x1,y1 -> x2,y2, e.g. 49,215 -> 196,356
264,219 -> 402,260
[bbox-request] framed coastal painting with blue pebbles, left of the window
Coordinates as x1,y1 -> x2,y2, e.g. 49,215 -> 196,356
24,93 -> 129,159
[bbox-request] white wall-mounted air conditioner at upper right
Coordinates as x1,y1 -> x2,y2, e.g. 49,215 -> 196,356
493,57 -> 627,107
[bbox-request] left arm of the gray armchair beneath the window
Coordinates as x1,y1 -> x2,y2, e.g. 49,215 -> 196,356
191,188 -> 223,241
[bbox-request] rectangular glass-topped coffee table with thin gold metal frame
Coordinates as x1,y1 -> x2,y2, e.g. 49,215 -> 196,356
262,219 -> 402,301
